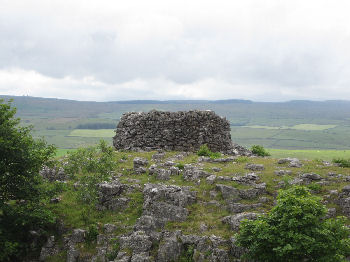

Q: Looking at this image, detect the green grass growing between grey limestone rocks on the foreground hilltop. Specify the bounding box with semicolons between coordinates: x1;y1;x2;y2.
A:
42;146;350;261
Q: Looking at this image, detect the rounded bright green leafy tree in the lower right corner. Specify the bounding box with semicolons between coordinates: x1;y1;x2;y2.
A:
236;186;350;262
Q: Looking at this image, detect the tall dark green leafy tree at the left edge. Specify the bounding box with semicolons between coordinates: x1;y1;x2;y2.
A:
0;100;55;261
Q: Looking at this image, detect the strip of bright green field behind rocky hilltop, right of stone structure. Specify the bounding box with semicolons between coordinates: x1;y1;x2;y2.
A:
267;149;350;161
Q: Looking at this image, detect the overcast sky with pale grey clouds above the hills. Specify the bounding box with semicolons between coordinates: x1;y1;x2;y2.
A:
0;0;350;101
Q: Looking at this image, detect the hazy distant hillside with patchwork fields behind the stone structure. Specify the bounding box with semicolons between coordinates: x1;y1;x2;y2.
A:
0;96;350;149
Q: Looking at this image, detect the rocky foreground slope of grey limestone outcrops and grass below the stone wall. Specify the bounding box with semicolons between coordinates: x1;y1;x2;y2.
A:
40;151;350;262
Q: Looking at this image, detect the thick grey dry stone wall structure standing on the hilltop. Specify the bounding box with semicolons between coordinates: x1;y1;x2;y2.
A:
113;110;235;154
